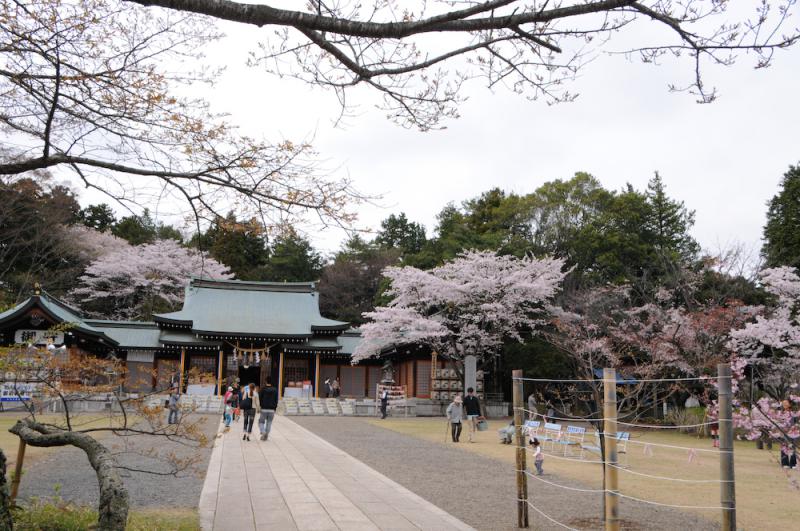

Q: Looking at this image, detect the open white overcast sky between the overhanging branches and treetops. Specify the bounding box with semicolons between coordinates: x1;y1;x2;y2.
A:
83;7;800;258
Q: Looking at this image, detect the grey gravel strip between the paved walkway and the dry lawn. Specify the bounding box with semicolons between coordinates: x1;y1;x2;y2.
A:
290;417;718;530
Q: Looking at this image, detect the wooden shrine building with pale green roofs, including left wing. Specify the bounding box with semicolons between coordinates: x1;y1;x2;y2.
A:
0;278;444;399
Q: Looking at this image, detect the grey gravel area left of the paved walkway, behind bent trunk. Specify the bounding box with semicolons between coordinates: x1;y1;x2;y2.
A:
15;415;220;508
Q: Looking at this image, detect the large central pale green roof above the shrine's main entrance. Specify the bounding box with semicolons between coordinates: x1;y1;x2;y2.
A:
155;278;349;337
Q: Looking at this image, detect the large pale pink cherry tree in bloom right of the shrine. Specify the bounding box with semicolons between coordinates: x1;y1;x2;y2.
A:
353;251;567;365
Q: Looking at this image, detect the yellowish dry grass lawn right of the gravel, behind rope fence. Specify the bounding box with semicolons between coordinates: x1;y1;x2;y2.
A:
369;418;800;529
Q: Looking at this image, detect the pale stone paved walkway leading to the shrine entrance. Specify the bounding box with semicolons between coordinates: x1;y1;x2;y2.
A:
200;415;472;531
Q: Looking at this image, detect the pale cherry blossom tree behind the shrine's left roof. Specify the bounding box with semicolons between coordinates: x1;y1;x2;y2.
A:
69;240;232;319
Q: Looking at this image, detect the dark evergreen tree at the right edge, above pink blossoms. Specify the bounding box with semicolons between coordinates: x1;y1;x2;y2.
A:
761;165;800;268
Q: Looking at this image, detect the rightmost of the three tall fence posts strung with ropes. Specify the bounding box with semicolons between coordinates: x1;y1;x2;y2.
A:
717;363;736;531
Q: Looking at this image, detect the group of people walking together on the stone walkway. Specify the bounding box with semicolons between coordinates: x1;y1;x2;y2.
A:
223;378;278;441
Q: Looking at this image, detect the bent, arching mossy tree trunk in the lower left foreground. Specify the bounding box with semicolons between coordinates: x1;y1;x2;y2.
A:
9;420;128;531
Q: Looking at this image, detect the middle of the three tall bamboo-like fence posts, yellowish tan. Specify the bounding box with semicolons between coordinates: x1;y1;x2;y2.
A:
603;369;619;531
